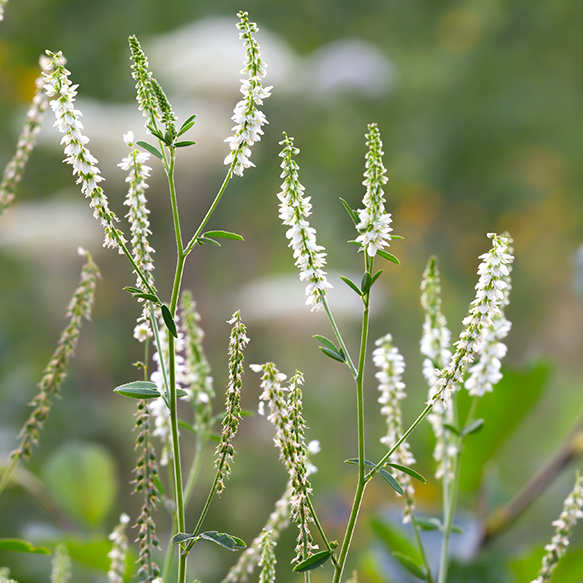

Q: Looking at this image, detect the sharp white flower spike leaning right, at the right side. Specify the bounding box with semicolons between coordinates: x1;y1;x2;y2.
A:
432;233;514;405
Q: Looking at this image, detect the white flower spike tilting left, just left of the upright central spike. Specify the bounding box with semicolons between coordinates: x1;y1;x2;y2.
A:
277;132;332;311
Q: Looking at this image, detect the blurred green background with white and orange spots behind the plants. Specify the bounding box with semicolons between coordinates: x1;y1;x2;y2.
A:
0;0;583;583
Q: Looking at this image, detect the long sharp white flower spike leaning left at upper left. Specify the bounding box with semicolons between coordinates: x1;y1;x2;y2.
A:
42;51;125;253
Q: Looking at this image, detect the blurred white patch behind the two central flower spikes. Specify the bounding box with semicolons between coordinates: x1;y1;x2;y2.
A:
237;272;387;322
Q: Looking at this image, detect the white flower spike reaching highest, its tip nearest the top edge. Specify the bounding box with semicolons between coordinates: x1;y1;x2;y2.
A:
225;12;272;176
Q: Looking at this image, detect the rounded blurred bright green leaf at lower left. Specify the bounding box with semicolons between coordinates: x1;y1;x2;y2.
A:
42;441;118;526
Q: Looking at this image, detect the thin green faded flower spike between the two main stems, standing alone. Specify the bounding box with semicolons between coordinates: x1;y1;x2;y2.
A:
215;311;249;494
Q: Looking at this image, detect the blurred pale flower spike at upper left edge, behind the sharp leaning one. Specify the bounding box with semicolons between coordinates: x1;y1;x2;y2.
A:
0;66;49;216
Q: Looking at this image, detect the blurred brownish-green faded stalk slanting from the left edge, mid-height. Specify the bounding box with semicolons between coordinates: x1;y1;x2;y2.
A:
0;248;100;492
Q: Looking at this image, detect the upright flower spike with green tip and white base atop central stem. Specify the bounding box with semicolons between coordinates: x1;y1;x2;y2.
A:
356;123;393;257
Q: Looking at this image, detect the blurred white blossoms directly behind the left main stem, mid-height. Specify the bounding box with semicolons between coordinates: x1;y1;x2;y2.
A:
148;314;191;466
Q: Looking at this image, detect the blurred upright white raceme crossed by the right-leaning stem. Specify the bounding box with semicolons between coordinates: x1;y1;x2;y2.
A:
421;257;457;478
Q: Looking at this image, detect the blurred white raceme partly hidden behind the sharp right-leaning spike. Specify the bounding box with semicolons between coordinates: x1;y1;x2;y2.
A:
464;238;512;397
